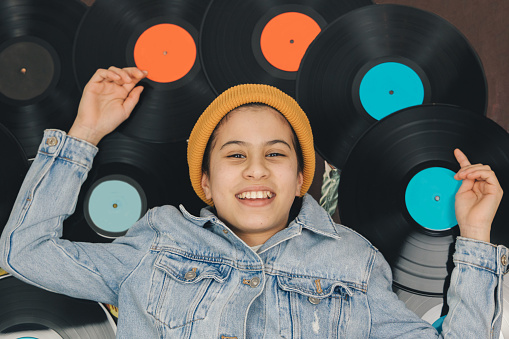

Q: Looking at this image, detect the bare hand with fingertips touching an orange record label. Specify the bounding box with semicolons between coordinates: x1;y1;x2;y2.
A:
68;67;147;145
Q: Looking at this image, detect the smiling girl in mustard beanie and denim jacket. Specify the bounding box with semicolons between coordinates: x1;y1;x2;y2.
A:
0;67;508;339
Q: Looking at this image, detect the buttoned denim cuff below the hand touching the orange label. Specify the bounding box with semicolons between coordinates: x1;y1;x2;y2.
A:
39;129;99;169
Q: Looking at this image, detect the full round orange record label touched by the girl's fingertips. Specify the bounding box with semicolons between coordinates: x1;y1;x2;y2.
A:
134;24;196;83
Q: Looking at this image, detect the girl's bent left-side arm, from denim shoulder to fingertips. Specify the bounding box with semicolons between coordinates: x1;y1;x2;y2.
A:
0;68;151;304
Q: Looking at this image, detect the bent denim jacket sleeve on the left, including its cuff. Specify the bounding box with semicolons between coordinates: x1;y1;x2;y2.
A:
0;130;154;305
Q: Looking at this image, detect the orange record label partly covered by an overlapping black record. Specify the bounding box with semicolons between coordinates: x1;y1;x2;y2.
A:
260;12;321;72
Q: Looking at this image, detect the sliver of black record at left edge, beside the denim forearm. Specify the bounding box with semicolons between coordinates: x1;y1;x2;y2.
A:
0;124;28;234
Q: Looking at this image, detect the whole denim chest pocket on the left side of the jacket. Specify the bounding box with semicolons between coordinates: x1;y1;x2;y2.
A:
147;252;231;329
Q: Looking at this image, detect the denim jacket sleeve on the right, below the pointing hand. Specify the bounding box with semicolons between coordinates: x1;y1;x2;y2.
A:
367;237;508;339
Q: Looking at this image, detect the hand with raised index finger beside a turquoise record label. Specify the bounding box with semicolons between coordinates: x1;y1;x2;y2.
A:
454;149;503;242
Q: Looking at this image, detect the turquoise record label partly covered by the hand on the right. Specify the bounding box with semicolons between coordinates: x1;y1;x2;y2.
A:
405;167;461;231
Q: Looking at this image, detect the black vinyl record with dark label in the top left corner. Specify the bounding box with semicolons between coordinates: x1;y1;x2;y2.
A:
0;0;86;158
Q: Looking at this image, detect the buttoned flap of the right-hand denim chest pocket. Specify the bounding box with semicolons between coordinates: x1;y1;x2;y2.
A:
277;276;353;298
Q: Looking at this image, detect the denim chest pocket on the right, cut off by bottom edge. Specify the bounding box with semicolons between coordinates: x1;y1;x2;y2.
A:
277;276;353;339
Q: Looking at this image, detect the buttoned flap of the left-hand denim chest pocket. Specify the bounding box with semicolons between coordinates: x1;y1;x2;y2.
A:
155;251;232;283
